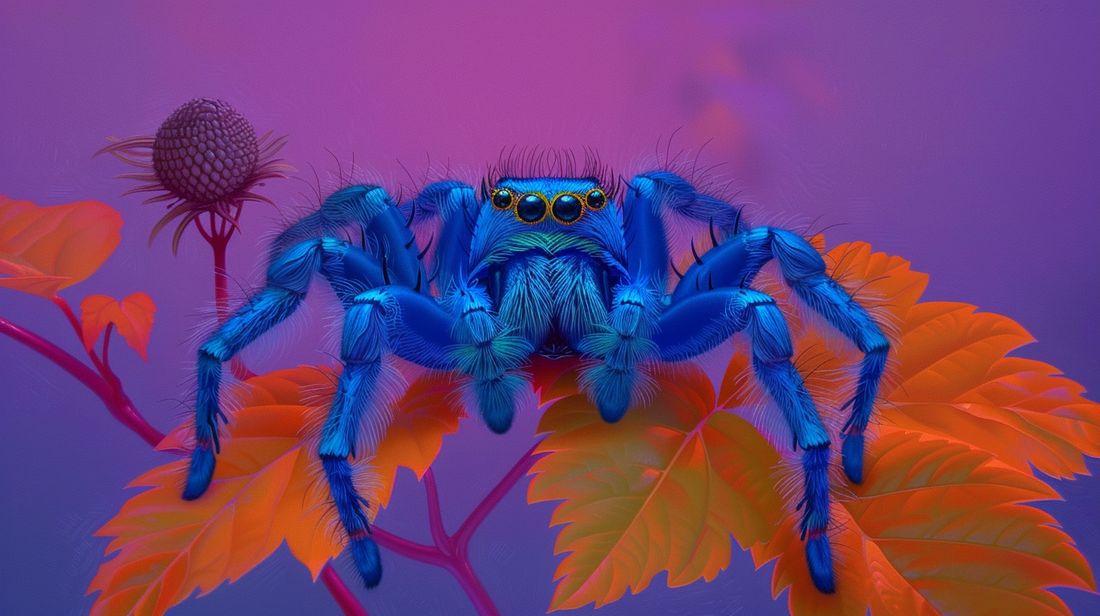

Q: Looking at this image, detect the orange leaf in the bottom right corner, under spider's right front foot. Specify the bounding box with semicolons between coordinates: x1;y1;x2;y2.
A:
752;428;1096;616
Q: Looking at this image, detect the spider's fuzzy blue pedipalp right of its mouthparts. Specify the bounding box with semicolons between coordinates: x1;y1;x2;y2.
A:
580;281;660;424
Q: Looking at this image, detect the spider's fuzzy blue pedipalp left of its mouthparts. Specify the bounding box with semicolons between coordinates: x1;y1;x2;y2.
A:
444;278;531;435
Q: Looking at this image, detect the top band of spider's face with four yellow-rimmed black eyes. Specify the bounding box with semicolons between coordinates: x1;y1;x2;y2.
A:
486;177;611;224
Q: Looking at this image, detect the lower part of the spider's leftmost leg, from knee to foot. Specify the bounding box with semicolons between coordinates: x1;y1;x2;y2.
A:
183;240;323;501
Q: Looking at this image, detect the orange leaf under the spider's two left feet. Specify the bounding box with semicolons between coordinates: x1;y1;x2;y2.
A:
88;366;461;615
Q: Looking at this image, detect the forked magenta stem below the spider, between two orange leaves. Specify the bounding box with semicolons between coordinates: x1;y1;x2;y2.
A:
374;443;541;616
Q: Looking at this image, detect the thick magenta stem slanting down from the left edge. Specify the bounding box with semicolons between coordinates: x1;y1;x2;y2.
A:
0;318;164;447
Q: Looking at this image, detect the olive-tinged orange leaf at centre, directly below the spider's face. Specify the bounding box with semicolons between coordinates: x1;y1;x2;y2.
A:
528;366;781;609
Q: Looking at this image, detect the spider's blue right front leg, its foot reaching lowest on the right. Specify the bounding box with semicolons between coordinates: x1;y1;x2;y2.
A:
653;288;835;593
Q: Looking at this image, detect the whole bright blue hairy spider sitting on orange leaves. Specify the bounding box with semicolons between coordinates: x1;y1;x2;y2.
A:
184;165;889;593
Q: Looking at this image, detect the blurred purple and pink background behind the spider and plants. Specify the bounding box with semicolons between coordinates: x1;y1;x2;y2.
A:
0;1;1100;616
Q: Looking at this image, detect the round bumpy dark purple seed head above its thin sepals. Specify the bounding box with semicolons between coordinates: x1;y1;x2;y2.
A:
153;98;260;205
